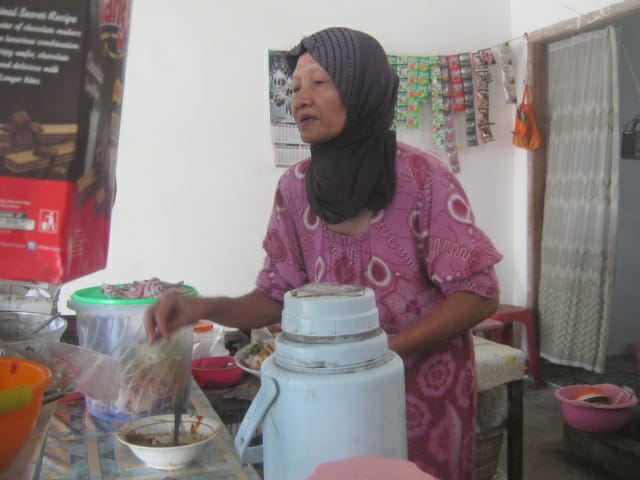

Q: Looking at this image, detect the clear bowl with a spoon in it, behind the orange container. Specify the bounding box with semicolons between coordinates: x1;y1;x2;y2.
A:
0;311;67;362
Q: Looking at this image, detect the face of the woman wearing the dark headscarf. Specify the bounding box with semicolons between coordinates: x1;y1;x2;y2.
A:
292;53;347;144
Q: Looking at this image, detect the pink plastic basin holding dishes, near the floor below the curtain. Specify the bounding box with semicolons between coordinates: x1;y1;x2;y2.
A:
555;383;638;433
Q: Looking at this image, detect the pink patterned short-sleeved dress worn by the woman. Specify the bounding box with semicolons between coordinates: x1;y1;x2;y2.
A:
257;143;502;480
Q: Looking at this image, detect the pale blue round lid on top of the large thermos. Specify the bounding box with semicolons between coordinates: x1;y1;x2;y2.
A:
282;283;380;337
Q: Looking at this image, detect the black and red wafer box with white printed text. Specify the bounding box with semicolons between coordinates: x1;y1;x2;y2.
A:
0;0;132;284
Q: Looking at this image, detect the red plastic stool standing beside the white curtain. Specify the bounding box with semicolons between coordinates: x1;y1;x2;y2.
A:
473;305;543;389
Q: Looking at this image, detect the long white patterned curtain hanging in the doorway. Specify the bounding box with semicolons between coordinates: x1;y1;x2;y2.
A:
539;27;620;372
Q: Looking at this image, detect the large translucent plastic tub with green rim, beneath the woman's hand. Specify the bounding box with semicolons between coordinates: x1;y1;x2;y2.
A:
68;286;197;422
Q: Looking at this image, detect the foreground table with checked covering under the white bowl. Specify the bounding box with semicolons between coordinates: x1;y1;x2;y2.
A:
14;379;261;480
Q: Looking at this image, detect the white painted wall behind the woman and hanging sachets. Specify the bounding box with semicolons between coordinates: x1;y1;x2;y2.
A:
60;0;611;311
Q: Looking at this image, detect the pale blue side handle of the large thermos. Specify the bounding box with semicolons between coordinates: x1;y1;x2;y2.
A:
234;375;278;463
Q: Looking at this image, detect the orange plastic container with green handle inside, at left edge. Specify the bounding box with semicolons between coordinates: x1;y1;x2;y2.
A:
0;357;51;472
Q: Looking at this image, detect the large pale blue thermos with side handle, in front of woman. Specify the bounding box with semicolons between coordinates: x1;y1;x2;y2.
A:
235;284;407;480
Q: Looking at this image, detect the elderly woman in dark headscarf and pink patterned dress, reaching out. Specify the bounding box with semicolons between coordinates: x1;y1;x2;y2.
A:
145;28;501;480
